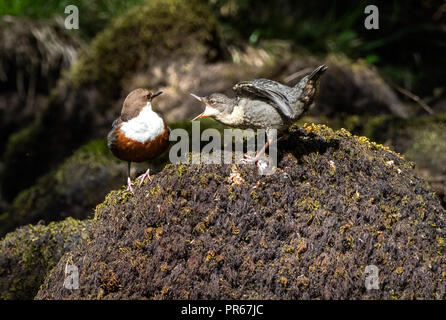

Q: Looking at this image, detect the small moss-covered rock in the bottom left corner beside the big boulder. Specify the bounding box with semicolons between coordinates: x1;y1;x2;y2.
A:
0;218;92;299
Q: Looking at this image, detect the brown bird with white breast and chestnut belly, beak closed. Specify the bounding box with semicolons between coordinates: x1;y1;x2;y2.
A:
107;89;170;192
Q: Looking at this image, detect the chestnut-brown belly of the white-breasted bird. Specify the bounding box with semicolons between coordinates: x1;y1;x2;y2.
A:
111;125;169;162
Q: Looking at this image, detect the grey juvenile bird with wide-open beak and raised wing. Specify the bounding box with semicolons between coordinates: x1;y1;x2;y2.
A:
191;65;327;162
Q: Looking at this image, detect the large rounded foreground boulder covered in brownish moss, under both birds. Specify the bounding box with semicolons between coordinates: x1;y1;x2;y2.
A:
36;125;446;299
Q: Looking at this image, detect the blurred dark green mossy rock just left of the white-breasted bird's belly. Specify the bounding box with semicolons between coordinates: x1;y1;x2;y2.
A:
0;139;127;235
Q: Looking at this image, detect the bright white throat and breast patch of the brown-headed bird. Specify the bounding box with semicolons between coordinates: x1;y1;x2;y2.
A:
121;102;164;143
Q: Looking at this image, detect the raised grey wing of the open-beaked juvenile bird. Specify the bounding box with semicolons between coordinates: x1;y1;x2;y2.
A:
232;79;295;119
